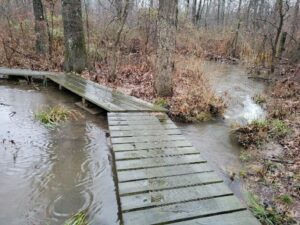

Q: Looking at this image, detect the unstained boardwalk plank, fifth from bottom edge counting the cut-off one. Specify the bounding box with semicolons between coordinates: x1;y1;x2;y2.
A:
118;163;212;182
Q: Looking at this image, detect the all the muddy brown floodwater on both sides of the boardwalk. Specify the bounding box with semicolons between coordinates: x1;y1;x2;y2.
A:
0;63;264;225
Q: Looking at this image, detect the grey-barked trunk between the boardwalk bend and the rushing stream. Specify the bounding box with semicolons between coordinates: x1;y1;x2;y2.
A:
155;0;178;96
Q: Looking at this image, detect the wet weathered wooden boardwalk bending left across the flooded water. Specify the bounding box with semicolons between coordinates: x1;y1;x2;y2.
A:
0;68;260;225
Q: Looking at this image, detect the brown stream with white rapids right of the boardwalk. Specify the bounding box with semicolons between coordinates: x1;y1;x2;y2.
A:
178;62;265;198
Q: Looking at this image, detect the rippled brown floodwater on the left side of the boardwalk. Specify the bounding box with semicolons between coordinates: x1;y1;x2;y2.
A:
0;81;118;225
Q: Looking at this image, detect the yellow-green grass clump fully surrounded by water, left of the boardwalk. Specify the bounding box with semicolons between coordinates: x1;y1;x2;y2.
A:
35;105;81;127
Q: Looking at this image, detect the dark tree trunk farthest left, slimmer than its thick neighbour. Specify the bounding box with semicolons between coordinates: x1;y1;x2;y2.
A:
32;0;47;54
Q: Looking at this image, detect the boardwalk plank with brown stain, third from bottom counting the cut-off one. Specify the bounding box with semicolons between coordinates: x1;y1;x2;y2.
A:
121;183;233;212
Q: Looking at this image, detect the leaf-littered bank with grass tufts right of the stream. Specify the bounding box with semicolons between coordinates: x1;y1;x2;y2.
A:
234;65;300;225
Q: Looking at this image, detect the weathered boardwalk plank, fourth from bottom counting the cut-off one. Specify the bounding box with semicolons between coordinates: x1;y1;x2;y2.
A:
119;171;222;196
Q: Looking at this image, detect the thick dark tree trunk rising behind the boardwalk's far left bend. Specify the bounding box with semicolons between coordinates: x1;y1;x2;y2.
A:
62;0;87;73
